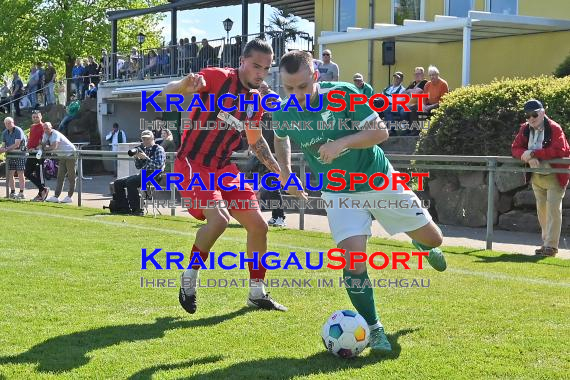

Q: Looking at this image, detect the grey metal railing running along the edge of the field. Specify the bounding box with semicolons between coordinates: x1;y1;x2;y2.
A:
6;150;570;250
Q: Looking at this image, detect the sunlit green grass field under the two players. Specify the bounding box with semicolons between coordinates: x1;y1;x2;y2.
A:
0;201;570;379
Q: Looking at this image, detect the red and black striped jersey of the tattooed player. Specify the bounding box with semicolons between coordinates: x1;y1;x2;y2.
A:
177;67;263;169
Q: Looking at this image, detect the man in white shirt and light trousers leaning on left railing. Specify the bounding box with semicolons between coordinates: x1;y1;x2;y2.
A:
42;122;76;203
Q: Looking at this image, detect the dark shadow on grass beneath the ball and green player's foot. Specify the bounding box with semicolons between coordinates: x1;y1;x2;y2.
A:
182;328;418;380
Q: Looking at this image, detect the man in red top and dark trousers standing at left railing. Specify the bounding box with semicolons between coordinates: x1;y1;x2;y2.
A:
24;111;49;202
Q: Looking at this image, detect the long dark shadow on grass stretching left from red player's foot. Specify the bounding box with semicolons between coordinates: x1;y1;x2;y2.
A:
0;307;251;373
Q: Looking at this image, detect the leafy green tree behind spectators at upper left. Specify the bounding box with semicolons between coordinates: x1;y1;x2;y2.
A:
0;0;164;91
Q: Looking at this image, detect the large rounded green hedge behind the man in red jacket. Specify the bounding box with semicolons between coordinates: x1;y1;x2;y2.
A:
417;76;570;156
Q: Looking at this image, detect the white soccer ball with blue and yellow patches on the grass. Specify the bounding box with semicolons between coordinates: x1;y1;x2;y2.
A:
321;310;370;359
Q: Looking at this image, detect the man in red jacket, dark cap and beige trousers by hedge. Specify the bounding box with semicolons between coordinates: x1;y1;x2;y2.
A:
511;99;570;256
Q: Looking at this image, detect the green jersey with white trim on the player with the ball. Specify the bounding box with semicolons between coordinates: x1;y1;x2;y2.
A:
273;82;390;192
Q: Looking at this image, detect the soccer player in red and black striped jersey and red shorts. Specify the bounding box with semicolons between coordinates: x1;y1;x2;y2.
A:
163;39;287;314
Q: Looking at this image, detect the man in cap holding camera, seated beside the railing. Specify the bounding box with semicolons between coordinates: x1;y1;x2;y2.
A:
113;130;166;216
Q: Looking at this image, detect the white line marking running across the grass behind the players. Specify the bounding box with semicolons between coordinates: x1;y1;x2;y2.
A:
0;208;570;287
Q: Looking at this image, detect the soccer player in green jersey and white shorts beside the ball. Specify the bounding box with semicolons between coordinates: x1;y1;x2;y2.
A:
273;51;447;353
